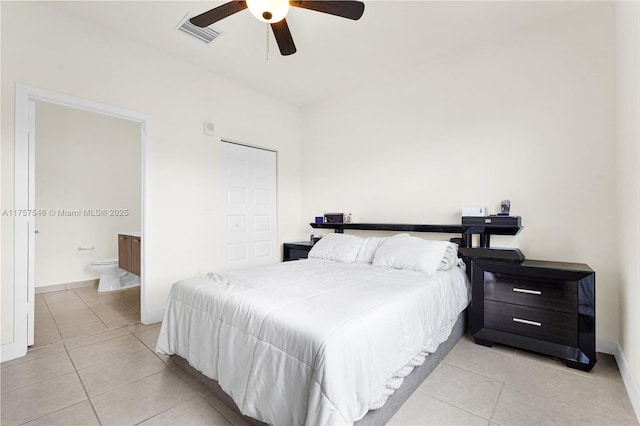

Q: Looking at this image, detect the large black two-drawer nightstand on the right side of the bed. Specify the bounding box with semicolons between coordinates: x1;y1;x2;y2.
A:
471;259;596;371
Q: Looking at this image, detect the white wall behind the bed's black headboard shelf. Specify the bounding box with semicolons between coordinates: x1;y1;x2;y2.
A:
302;2;618;342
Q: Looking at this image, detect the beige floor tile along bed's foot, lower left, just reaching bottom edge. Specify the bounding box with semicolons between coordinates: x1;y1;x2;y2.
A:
92;369;197;425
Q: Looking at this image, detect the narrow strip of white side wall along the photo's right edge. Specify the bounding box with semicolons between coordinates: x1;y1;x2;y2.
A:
616;2;640;419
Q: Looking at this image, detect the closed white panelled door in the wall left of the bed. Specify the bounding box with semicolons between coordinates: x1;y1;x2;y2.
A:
221;142;278;269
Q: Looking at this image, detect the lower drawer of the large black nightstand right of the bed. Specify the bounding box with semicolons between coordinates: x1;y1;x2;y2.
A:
484;300;578;346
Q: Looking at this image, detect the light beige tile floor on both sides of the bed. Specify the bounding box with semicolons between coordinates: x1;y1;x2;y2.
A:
0;289;638;426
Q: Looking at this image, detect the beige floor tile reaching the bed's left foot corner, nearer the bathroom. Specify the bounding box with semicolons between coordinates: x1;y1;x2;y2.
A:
78;349;167;397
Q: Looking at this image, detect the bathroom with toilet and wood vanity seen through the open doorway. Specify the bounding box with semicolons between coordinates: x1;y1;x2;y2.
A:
34;101;142;345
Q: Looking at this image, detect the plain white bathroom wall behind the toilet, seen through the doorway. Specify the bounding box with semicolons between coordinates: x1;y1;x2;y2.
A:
35;102;142;287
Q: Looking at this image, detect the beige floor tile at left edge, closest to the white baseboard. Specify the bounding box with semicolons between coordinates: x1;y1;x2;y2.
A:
2;351;74;394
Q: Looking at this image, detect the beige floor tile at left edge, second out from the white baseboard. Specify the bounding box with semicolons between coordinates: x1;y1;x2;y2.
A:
0;371;87;426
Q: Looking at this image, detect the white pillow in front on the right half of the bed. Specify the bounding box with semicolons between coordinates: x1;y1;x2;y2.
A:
372;236;457;275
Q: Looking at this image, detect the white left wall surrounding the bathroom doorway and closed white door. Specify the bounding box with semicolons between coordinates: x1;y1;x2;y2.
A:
0;1;301;343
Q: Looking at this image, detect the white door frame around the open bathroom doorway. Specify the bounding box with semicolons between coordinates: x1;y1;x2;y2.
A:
2;84;152;361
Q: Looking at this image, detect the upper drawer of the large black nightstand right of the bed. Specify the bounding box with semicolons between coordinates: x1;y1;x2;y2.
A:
484;271;578;313
